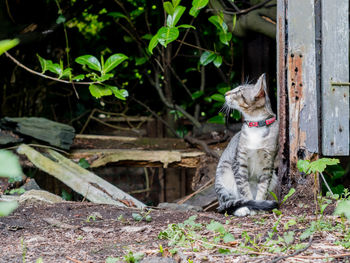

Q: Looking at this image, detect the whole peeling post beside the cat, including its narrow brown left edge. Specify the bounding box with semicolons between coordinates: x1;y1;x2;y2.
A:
277;0;319;182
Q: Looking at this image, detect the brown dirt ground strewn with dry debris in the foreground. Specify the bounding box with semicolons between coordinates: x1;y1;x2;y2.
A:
0;202;350;263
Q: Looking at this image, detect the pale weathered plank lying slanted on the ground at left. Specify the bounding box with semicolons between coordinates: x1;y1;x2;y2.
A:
17;144;145;208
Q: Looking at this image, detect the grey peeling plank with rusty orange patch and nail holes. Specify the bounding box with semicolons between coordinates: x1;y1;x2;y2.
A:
287;0;319;174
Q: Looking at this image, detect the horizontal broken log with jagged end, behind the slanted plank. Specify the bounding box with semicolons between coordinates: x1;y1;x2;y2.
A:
69;149;205;168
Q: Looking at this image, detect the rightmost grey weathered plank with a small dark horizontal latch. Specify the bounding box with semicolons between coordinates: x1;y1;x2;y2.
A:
322;0;349;155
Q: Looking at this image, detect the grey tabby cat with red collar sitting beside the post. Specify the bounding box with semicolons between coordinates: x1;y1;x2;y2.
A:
215;74;278;216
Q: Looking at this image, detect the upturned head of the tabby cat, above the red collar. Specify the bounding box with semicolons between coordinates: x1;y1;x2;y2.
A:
225;74;274;117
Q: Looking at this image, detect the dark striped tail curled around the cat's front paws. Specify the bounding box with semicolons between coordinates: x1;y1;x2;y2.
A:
218;199;278;214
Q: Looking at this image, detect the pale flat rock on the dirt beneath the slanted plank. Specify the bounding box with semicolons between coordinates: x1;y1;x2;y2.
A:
18;190;64;205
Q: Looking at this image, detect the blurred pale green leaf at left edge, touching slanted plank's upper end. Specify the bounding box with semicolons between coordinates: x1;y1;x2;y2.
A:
0;150;22;179
